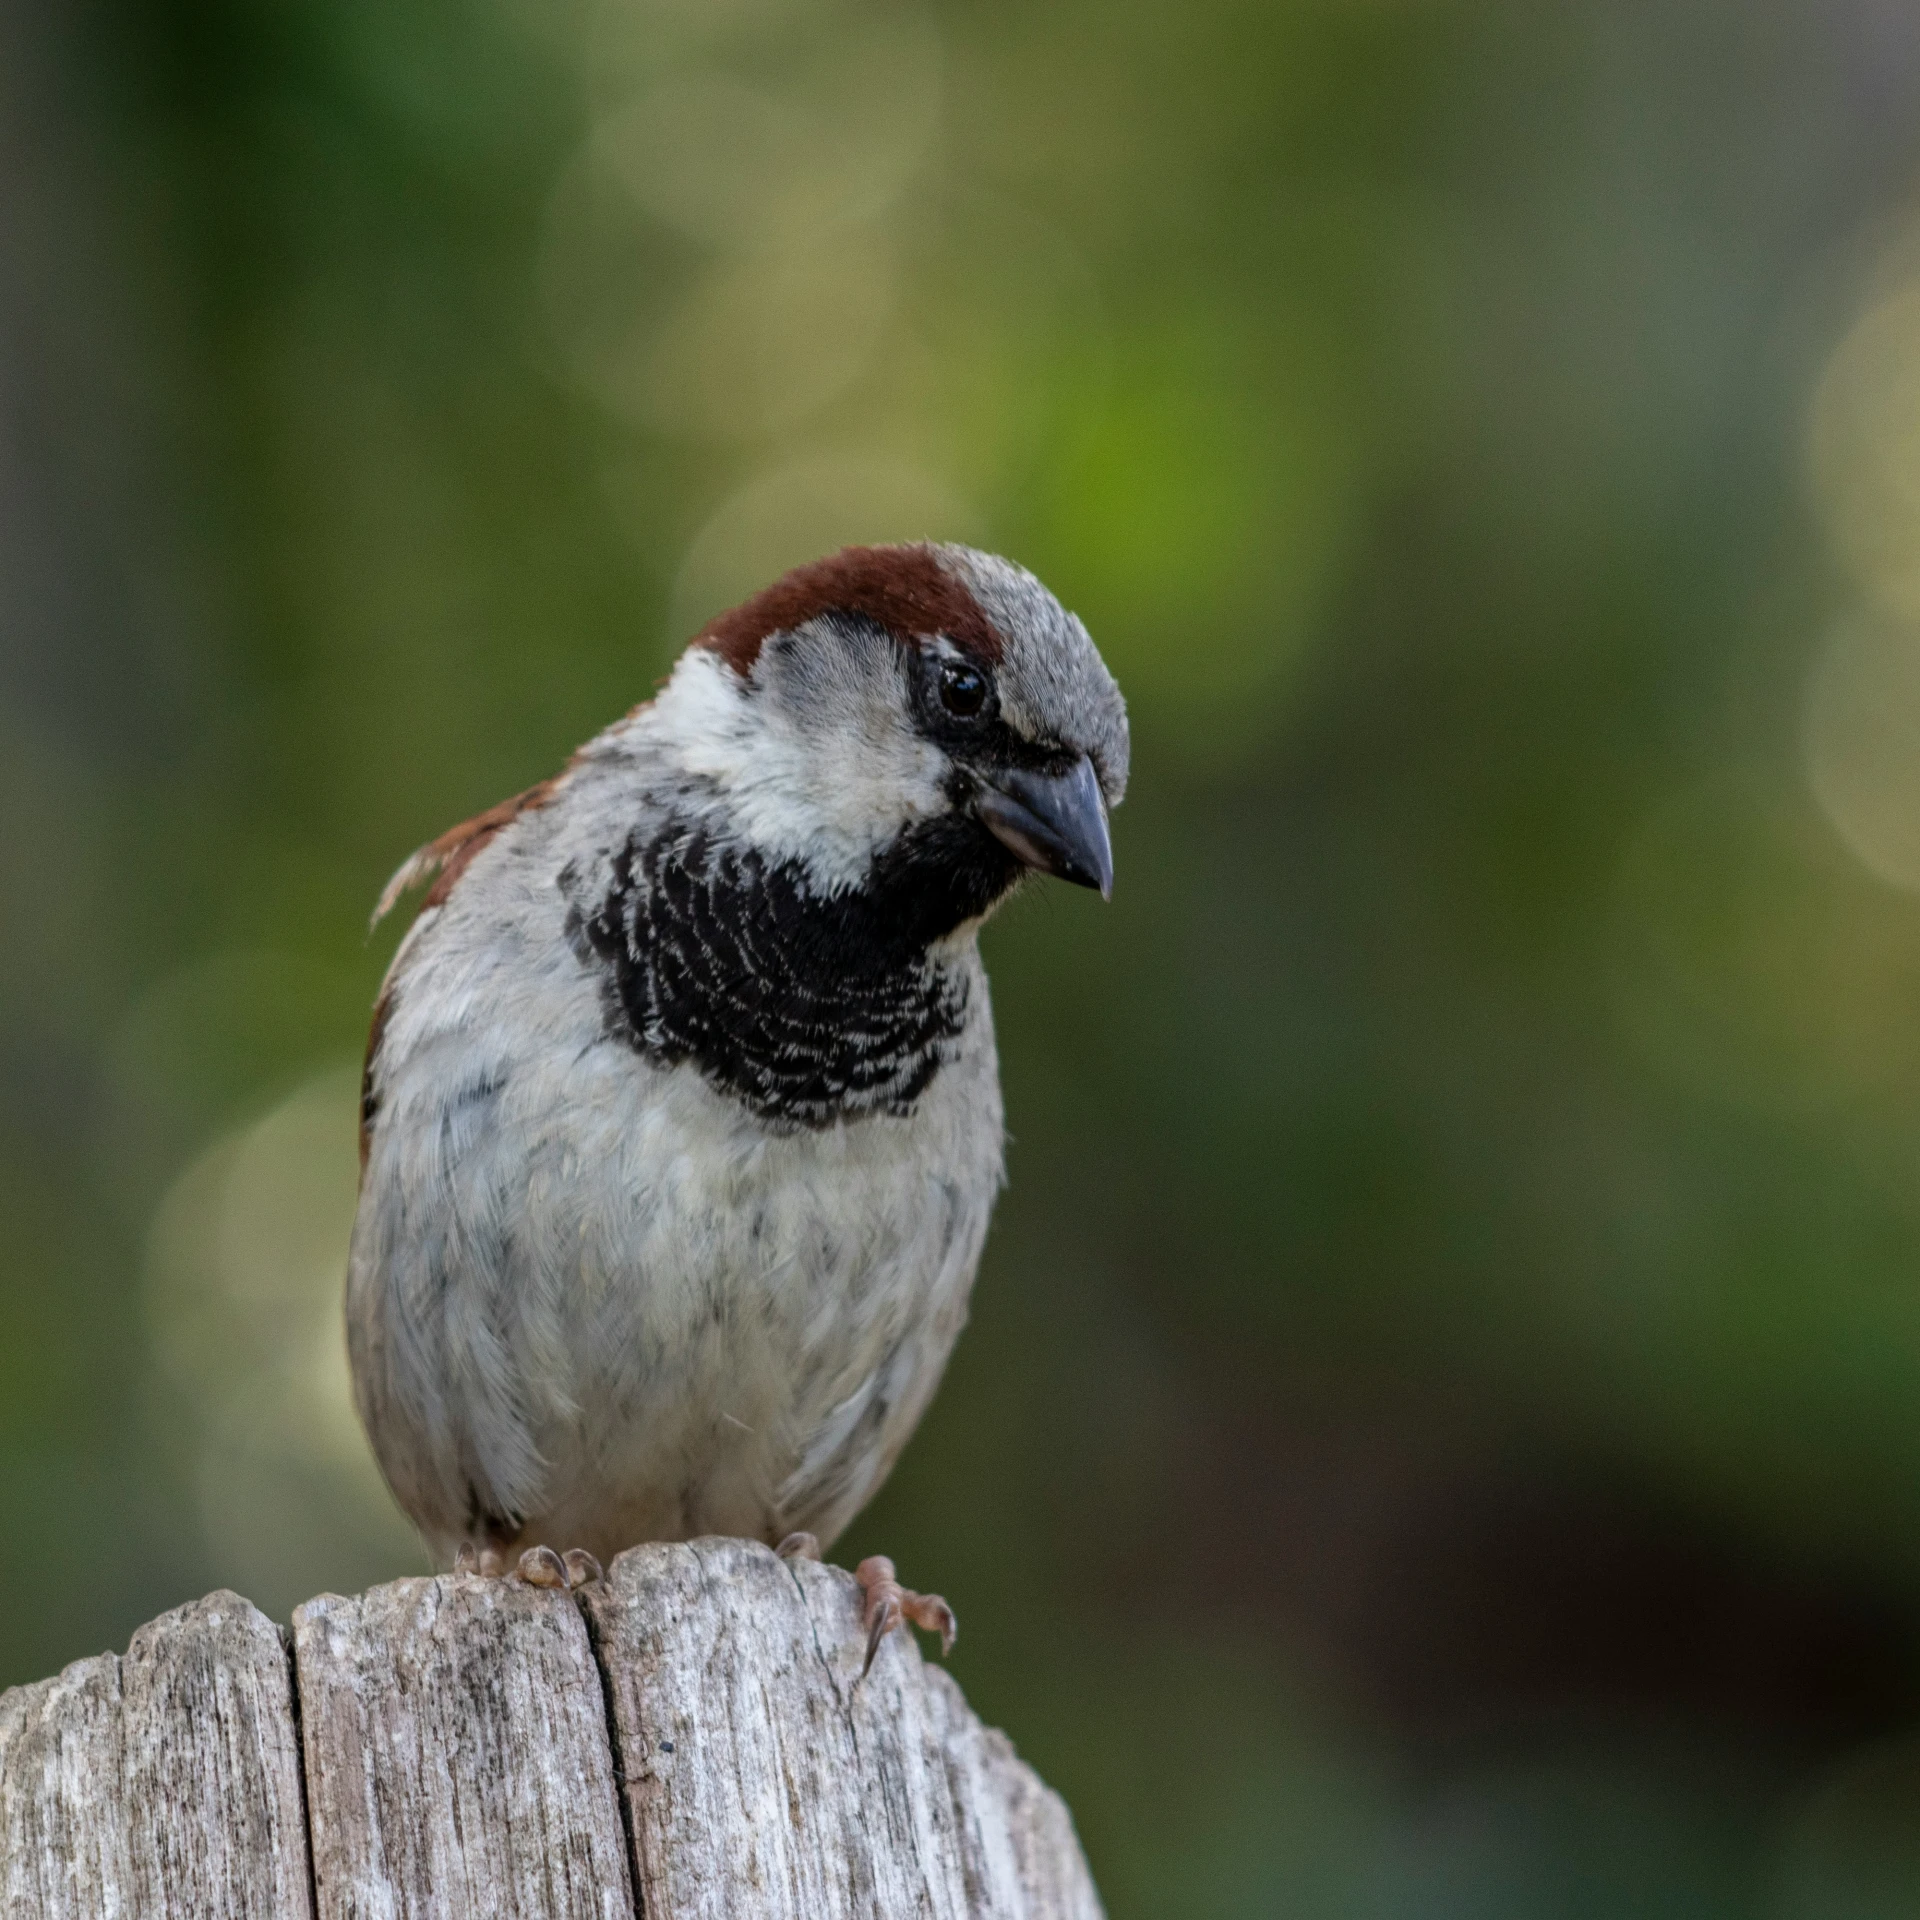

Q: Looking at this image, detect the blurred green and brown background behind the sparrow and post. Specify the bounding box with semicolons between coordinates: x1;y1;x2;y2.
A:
11;0;1920;1920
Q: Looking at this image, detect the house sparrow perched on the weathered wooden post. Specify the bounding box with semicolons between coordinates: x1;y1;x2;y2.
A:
346;545;1127;1657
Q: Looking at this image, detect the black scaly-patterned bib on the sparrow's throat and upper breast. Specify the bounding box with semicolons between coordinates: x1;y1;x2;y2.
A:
561;814;1020;1127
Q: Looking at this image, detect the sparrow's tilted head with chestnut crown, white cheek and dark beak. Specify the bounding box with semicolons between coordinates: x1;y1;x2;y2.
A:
655;545;1127;924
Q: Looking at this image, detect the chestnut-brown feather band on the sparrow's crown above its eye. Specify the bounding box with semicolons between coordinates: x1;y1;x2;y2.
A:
693;543;1002;674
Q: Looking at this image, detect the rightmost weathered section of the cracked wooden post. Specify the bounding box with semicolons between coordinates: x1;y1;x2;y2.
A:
584;1540;1100;1920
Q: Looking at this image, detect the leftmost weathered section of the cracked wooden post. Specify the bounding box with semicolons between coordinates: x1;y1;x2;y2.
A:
0;1594;313;1920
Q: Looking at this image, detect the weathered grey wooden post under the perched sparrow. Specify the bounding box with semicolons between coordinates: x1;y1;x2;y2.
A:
0;1540;1100;1920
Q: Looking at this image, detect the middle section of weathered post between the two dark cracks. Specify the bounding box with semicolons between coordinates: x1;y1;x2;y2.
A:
294;1574;634;1920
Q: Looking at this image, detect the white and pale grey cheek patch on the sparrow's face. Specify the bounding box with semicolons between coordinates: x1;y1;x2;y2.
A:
653;634;948;889
